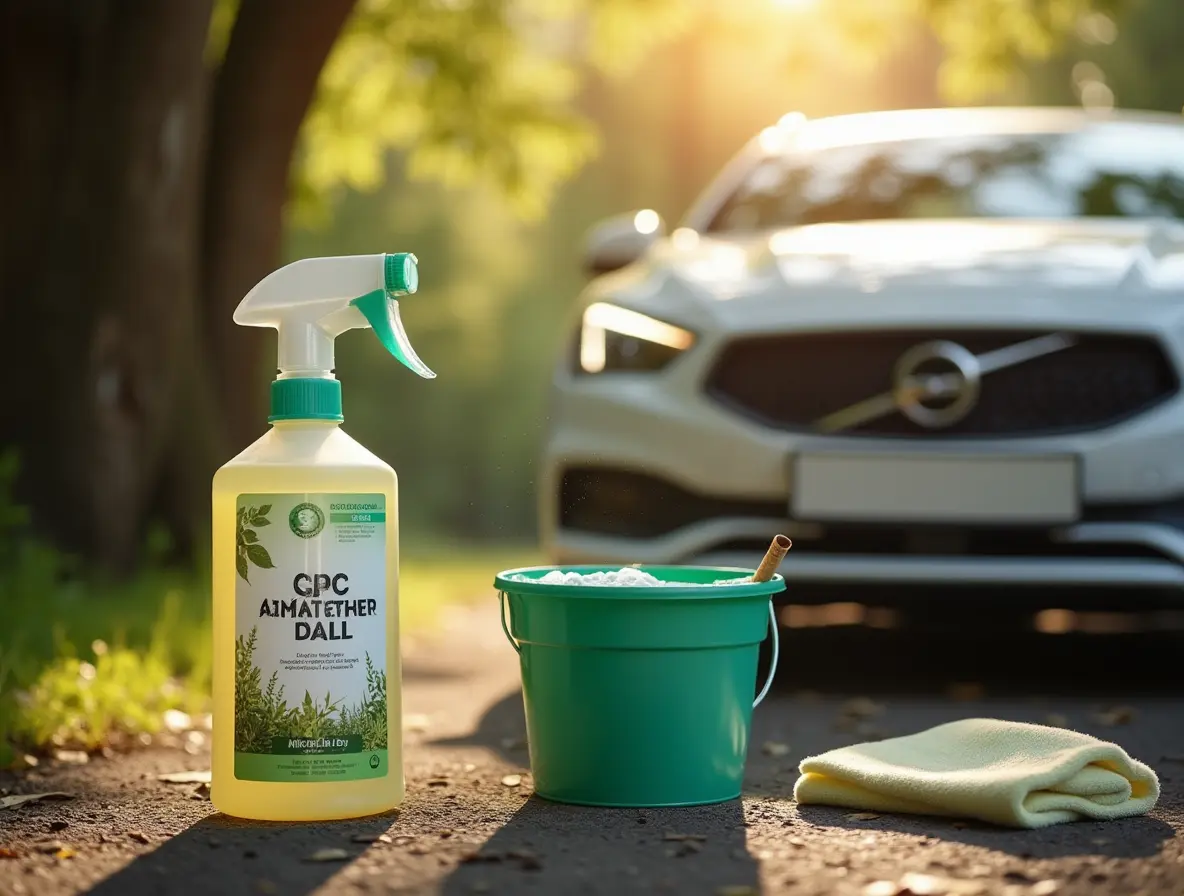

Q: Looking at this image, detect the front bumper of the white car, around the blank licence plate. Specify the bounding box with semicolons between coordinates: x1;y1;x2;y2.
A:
540;343;1184;589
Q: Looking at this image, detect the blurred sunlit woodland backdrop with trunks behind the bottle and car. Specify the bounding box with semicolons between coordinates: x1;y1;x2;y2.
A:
0;0;1146;569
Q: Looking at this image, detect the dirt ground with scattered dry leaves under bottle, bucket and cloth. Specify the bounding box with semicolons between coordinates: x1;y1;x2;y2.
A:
0;607;1184;896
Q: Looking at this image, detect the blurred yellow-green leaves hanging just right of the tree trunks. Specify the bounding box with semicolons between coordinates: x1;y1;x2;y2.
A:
292;0;688;224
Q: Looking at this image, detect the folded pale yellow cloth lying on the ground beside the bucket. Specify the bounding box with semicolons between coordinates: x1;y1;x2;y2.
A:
793;718;1159;827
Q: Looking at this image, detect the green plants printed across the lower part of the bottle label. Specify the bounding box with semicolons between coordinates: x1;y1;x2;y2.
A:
234;629;387;753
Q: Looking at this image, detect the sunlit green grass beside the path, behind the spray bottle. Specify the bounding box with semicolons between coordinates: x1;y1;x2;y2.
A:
0;485;536;768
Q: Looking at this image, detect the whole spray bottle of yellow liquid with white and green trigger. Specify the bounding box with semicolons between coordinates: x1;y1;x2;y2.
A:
211;253;436;821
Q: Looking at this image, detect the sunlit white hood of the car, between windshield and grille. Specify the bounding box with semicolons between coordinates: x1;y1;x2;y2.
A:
591;219;1184;329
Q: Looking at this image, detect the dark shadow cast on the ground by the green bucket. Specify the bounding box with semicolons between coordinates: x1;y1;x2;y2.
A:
442;797;759;896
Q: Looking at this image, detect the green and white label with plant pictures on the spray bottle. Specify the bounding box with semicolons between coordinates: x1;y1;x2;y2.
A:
234;494;388;784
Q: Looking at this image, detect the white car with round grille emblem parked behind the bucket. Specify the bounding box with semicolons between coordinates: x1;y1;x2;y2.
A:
540;109;1184;597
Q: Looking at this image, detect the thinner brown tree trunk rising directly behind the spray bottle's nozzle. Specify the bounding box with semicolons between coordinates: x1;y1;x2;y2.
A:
202;0;355;451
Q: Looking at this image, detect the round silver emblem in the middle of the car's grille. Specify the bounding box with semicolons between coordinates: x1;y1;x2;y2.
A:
893;340;983;430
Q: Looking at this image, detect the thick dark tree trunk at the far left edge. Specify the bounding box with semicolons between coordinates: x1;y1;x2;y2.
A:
0;0;211;569
